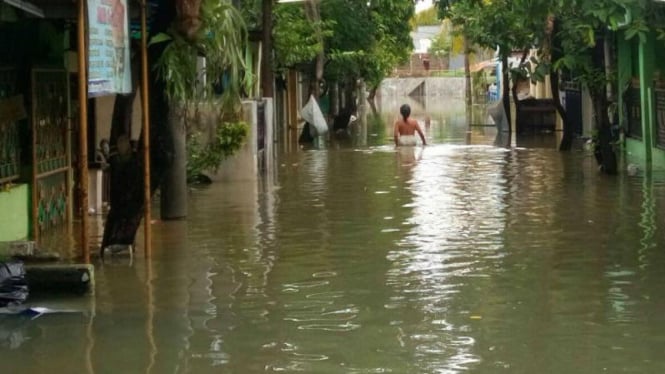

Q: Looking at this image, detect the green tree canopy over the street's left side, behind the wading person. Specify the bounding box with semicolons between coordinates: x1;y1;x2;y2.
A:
273;0;415;93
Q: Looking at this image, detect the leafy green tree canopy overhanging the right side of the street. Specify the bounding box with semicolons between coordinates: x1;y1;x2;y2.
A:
437;0;665;86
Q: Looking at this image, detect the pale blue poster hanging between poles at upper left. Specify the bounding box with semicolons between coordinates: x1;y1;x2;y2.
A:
88;0;132;97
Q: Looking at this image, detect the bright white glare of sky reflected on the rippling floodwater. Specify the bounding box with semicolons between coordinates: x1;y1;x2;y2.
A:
386;146;504;372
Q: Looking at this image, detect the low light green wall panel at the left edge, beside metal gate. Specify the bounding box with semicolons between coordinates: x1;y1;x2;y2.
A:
0;184;30;242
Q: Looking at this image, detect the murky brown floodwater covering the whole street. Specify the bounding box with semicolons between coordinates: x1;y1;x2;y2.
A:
0;103;665;374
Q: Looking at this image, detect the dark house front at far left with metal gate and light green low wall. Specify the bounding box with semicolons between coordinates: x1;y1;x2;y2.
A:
0;13;75;244
